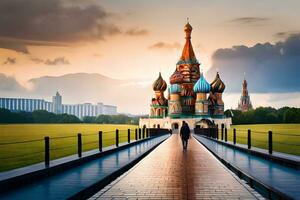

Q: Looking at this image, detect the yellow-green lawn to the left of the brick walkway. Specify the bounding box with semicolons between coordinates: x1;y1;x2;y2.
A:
0;124;137;171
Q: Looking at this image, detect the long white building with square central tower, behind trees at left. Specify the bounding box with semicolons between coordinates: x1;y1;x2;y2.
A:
0;92;118;119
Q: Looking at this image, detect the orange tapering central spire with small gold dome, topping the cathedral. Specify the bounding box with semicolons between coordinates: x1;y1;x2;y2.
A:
180;22;196;61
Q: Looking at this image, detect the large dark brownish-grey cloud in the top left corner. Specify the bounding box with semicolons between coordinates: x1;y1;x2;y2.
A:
0;0;121;53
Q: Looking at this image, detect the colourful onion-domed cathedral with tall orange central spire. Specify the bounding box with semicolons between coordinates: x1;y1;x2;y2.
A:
139;23;231;129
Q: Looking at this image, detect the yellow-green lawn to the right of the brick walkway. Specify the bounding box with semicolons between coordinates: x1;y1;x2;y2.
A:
224;124;300;155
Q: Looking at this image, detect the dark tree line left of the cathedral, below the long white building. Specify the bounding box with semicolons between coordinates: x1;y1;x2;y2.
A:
0;108;139;124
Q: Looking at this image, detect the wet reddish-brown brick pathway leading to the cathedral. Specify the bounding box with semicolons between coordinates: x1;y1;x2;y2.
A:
91;134;256;199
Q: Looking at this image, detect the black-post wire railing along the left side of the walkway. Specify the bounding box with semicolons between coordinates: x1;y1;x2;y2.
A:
0;128;169;171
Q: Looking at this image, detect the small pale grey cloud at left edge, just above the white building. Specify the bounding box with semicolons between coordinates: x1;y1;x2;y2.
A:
0;73;24;92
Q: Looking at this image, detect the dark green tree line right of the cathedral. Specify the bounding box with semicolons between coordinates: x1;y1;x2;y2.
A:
225;107;300;124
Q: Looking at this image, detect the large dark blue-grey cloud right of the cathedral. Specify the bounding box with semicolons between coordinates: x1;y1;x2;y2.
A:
207;34;300;93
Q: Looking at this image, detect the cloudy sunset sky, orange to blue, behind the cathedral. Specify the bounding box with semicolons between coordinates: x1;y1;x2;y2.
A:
0;0;300;114
